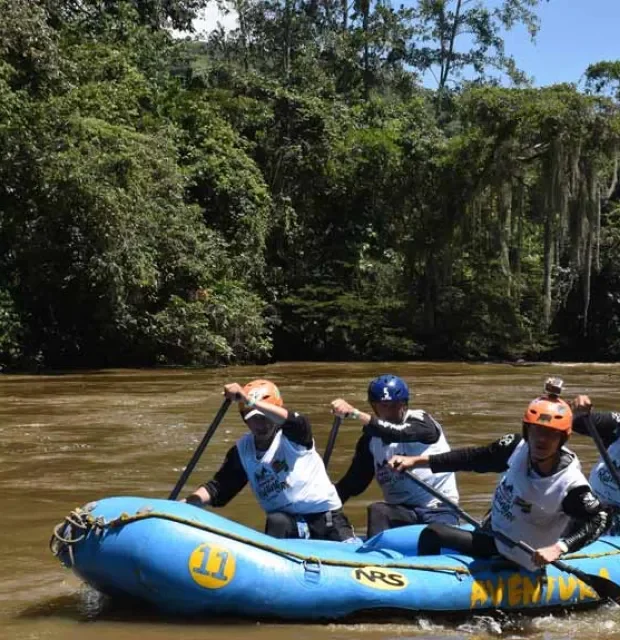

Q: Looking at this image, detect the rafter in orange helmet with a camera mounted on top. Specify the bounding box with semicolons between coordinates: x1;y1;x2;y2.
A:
388;396;608;571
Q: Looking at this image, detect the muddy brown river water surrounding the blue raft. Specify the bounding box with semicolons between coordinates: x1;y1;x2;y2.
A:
0;363;620;640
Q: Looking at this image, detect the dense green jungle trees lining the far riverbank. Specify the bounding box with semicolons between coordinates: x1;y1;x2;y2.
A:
0;0;620;371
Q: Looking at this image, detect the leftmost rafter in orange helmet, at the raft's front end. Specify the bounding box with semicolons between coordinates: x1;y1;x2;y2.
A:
185;380;354;541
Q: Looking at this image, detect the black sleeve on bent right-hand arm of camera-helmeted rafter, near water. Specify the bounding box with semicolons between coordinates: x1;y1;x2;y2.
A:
562;486;609;551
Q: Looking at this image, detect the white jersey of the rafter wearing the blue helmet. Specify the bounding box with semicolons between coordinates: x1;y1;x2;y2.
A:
370;409;459;509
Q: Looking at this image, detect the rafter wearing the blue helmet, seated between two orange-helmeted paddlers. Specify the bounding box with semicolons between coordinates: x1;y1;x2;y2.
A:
331;374;459;538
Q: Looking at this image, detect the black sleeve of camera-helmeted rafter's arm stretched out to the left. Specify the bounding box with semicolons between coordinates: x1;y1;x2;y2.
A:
429;433;521;473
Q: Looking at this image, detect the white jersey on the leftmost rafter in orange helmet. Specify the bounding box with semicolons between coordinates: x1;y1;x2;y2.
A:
237;430;342;515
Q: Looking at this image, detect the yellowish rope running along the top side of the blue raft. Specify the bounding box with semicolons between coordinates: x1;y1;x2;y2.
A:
50;508;620;579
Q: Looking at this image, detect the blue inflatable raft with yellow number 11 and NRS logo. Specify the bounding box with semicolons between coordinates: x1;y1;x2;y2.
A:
51;497;620;620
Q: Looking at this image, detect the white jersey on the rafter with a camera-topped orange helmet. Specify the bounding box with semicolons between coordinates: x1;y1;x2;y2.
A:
491;440;589;571
